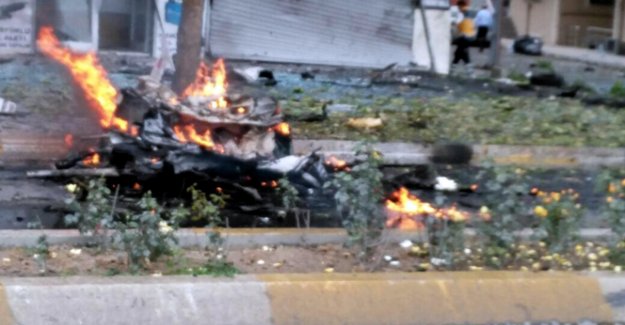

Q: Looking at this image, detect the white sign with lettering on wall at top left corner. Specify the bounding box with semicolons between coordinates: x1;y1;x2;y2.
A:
0;0;33;54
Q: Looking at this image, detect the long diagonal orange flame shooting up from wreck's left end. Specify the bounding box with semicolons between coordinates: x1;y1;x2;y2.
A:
37;27;128;132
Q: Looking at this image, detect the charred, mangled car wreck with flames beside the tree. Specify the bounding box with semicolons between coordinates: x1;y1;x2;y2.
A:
38;28;335;224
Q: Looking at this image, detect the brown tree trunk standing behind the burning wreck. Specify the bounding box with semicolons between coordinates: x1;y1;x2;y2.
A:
172;0;204;95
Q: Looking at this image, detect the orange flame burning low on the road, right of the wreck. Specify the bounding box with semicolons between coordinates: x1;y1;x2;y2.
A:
385;187;468;230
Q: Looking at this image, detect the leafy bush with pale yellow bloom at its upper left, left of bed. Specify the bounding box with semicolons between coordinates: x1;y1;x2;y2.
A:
65;178;119;248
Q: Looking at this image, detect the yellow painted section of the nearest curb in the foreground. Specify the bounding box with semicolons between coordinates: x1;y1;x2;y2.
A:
257;272;613;325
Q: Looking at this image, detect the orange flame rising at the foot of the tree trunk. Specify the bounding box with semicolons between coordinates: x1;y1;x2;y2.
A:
182;59;228;109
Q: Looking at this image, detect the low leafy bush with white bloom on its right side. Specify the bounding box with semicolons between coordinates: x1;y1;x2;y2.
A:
115;192;178;271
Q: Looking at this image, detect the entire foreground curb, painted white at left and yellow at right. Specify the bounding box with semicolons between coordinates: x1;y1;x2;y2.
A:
0;272;625;325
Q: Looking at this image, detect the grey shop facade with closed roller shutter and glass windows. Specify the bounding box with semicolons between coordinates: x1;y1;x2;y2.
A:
0;0;450;73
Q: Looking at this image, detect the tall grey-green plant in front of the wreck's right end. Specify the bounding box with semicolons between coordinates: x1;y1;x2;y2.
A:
325;144;385;261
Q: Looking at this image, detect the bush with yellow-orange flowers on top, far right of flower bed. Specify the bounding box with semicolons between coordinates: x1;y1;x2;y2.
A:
534;189;583;252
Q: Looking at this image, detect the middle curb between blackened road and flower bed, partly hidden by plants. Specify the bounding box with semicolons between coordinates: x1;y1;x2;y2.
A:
0;228;611;248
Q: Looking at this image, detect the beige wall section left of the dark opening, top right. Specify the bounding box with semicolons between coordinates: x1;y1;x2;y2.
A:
510;0;560;45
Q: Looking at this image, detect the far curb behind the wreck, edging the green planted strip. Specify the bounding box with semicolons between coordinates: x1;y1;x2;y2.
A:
0;135;625;168
